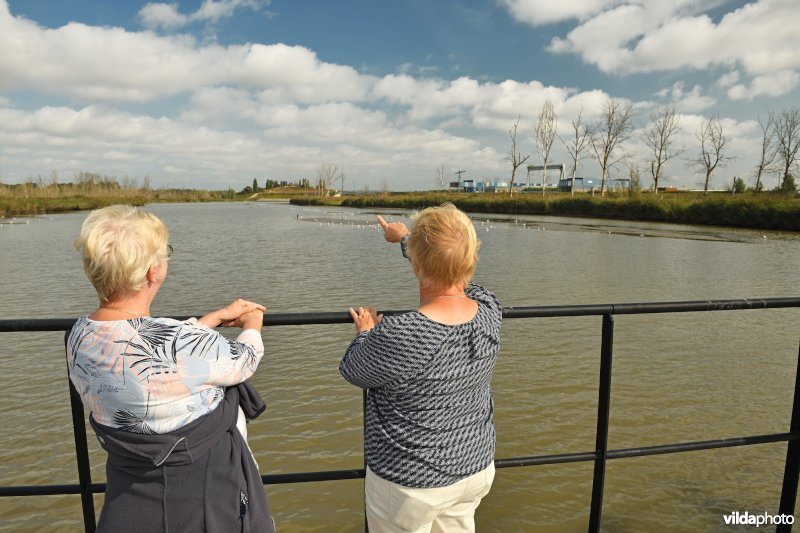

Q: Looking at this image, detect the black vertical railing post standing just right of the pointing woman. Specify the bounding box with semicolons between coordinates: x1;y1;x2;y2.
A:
589;314;614;532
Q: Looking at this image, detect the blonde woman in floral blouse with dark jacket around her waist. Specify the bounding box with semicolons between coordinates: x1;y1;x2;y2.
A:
67;205;274;532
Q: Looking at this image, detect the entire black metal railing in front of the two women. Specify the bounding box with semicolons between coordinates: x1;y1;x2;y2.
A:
0;297;800;533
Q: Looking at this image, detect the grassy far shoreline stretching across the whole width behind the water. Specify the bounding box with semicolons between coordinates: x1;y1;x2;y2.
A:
0;190;800;232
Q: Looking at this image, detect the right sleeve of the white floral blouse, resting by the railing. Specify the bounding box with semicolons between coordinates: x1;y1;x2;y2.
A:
175;319;264;386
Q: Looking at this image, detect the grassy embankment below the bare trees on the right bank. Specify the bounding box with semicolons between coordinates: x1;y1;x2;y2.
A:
291;193;800;231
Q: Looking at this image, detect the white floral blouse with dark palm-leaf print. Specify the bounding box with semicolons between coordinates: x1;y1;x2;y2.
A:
67;317;264;433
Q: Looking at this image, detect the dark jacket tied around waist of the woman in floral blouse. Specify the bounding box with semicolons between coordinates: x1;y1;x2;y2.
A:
89;382;274;533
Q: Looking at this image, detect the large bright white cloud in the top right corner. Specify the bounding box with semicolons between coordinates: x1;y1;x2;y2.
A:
524;0;800;98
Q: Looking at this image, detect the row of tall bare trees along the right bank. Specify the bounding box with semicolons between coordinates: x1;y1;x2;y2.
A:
504;97;800;195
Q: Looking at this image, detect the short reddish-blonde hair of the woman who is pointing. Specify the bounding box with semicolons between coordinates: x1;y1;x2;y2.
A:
408;203;480;288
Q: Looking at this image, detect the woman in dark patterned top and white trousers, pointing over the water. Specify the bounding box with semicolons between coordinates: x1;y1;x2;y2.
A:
339;204;502;533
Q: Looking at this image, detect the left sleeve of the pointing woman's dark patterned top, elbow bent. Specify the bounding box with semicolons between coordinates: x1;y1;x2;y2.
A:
339;317;441;389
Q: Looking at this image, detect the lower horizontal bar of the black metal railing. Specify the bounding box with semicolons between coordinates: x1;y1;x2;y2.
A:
0;433;800;497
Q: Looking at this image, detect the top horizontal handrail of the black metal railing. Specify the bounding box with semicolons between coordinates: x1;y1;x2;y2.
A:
0;297;800;333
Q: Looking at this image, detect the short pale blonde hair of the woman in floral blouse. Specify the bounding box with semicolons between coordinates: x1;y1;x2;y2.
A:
75;205;169;303
